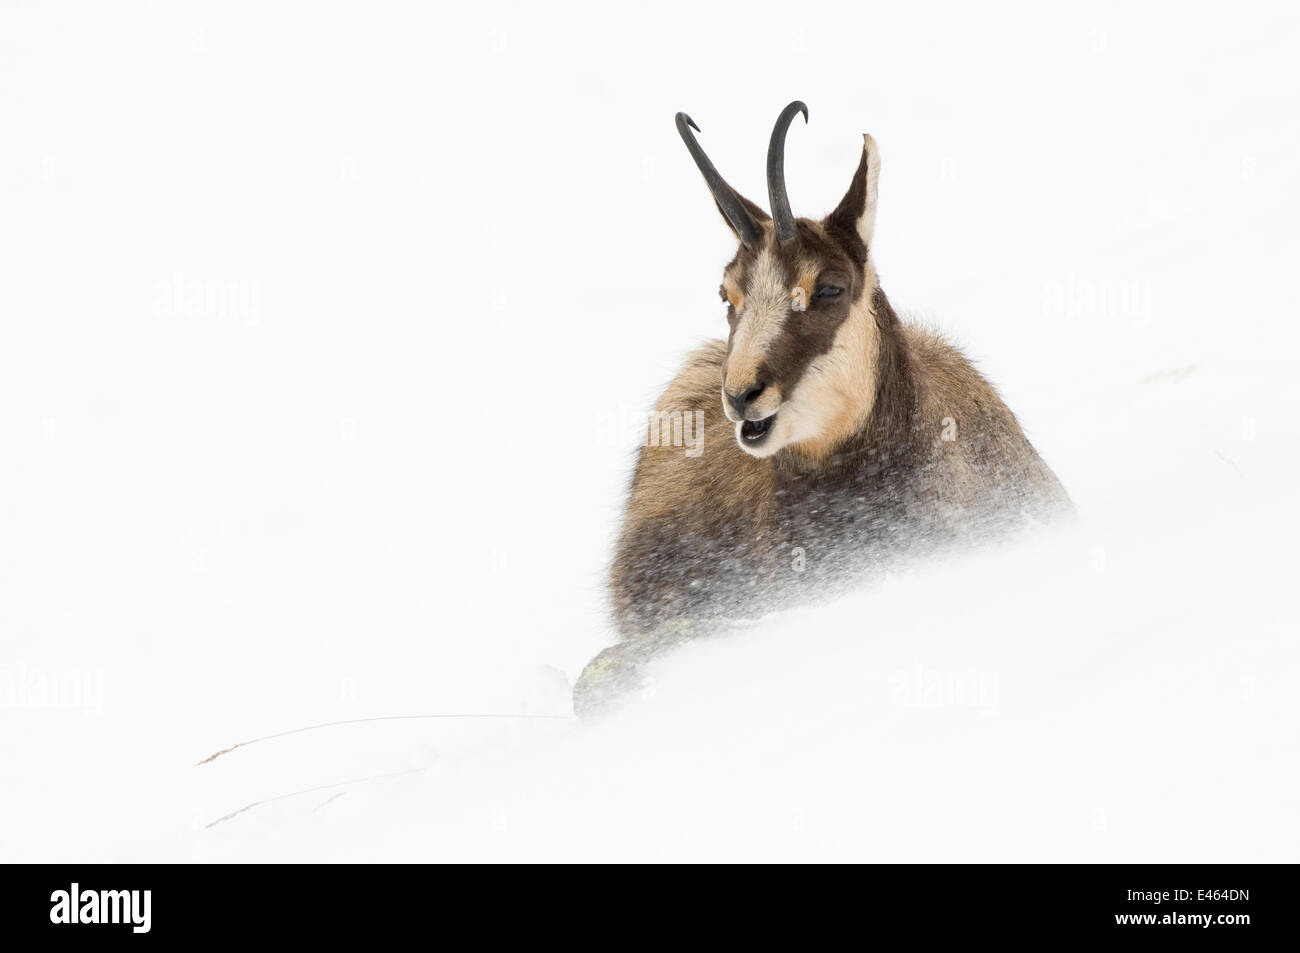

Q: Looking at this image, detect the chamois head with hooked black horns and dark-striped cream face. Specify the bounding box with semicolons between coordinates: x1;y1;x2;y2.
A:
677;103;880;459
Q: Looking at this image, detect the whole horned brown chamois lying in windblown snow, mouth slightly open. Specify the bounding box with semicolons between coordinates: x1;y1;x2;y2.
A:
575;103;1071;714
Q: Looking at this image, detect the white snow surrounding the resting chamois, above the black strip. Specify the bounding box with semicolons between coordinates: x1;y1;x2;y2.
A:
0;3;1300;862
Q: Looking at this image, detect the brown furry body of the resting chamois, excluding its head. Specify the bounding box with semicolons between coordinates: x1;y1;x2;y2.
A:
611;286;1070;637
